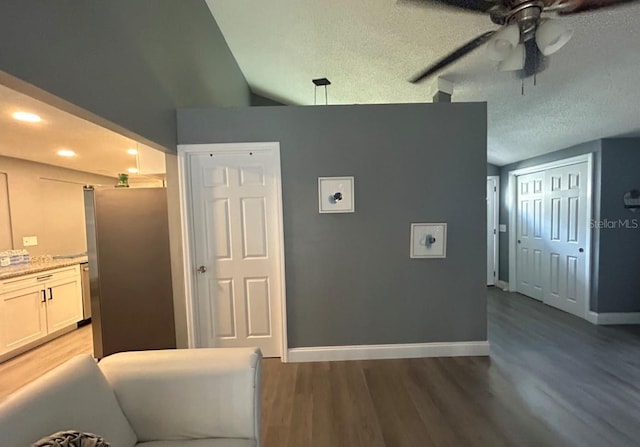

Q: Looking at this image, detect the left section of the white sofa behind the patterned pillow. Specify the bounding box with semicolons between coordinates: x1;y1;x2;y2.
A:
0;355;137;447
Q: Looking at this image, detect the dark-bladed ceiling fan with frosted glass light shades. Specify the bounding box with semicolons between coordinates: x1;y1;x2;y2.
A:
410;0;637;83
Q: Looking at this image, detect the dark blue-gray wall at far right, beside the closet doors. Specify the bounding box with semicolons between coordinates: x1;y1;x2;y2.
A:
594;138;640;312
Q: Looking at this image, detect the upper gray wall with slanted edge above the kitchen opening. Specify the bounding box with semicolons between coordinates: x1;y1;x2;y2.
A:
0;0;250;150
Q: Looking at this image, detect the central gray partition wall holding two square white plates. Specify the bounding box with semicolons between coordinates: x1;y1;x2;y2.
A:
178;103;487;347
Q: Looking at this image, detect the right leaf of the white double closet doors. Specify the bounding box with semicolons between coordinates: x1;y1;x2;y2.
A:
544;163;588;317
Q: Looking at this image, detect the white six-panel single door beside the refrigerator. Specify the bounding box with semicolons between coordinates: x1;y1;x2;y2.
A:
190;144;284;357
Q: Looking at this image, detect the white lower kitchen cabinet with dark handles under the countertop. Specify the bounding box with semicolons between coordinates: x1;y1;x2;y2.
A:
0;265;82;360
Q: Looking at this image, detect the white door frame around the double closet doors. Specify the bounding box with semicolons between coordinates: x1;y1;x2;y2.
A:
507;153;593;319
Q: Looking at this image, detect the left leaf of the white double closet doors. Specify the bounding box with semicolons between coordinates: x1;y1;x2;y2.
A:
516;172;545;301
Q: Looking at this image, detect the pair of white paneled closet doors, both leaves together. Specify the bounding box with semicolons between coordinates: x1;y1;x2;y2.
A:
516;162;589;318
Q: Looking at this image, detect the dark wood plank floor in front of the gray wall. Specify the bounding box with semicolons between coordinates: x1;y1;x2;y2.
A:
262;289;640;447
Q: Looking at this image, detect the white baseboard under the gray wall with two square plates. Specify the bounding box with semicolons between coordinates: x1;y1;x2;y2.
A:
288;341;489;362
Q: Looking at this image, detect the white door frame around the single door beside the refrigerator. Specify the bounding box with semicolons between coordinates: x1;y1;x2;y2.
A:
178;142;288;362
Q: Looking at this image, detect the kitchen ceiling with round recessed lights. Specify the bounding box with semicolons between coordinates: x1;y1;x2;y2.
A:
0;85;164;182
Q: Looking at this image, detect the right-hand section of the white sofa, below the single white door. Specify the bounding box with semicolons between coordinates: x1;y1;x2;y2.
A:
99;348;261;447
